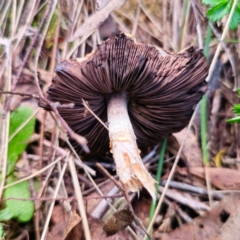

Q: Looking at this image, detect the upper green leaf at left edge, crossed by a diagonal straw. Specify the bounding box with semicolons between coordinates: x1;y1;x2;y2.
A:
7;106;35;174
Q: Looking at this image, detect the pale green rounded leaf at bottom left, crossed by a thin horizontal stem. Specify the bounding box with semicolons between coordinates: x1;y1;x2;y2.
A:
0;178;34;222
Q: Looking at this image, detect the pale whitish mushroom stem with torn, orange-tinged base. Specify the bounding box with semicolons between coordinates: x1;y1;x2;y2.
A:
107;93;156;199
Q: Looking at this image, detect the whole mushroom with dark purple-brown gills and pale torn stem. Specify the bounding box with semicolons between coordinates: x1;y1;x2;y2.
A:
43;33;208;198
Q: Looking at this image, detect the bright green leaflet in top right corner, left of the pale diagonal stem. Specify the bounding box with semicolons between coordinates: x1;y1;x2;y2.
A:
207;1;232;22
